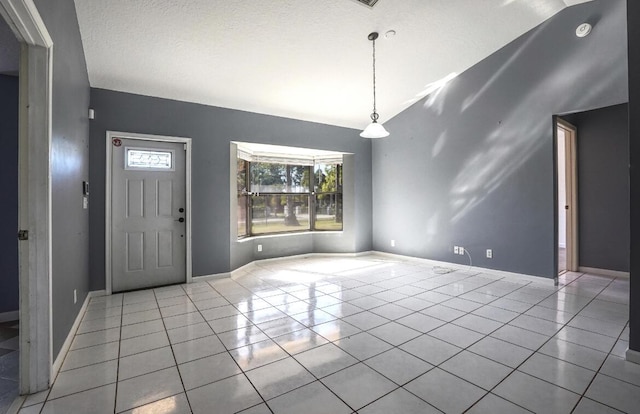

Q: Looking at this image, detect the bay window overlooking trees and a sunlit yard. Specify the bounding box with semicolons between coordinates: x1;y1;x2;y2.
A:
237;146;343;238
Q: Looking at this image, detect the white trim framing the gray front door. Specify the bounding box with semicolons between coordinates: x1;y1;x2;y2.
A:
104;131;193;295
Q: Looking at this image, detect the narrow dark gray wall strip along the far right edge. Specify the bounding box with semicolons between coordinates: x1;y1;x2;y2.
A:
627;0;640;352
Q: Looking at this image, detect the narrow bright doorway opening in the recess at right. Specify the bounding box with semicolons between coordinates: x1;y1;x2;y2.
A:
554;117;578;275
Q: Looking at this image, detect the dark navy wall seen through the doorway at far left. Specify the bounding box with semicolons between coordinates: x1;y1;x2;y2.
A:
0;75;19;313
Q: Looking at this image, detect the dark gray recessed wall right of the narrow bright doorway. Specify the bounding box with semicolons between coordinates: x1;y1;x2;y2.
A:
563;104;630;272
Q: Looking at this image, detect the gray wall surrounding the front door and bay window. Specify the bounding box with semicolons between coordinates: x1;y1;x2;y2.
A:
90;89;371;290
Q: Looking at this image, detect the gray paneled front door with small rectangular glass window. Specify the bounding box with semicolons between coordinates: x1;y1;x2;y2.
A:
111;137;188;292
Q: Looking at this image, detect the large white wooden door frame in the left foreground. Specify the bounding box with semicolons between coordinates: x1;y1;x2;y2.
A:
0;0;55;394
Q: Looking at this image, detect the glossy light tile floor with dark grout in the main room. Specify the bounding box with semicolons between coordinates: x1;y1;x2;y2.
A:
20;256;640;414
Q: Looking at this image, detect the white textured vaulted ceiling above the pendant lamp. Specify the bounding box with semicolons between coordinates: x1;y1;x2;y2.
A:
75;0;588;129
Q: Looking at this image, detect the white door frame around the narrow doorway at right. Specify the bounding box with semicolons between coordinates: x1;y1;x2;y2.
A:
553;116;579;279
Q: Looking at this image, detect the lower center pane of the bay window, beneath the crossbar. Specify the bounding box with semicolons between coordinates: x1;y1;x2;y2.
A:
251;195;310;234
